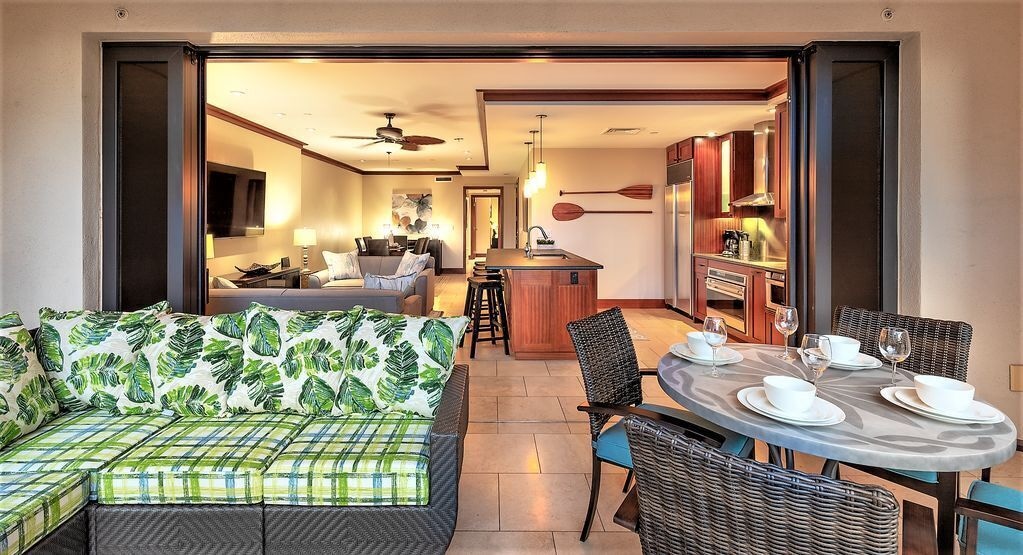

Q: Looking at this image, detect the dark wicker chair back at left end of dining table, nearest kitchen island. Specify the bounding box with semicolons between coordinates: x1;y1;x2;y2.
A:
568;307;642;436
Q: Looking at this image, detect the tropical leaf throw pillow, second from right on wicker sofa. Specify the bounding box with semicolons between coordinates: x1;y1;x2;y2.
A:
234;303;353;415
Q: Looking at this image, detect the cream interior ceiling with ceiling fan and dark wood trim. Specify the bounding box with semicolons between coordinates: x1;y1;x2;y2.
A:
207;61;786;175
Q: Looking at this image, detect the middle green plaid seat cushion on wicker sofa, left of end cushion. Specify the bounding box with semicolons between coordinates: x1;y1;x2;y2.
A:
97;413;309;504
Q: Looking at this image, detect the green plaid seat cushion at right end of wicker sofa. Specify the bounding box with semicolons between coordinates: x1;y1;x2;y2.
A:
263;413;433;505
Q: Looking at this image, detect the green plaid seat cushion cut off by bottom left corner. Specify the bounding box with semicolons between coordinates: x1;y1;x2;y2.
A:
0;472;89;555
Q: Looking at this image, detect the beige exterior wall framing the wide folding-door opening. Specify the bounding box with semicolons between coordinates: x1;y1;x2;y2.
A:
0;0;1023;423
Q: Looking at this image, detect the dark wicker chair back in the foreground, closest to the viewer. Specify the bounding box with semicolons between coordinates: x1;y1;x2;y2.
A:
625;416;899;555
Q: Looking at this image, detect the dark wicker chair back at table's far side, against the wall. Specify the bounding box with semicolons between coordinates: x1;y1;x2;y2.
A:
832;307;973;381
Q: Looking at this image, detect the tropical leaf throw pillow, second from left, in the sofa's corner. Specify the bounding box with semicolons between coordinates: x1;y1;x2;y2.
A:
36;300;171;414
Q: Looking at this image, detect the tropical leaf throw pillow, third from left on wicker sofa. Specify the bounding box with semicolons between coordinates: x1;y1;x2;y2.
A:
135;312;246;417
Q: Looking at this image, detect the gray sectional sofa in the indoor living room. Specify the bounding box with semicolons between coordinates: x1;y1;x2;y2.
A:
206;256;436;316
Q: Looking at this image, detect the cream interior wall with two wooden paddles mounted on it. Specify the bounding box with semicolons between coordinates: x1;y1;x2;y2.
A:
529;148;666;299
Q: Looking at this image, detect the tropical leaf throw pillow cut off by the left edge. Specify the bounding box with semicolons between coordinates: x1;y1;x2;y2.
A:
0;312;60;448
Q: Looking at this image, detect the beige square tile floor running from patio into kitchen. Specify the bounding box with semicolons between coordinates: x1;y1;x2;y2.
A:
436;275;1023;554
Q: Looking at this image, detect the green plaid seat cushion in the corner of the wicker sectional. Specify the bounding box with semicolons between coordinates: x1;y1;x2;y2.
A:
0;409;175;499
